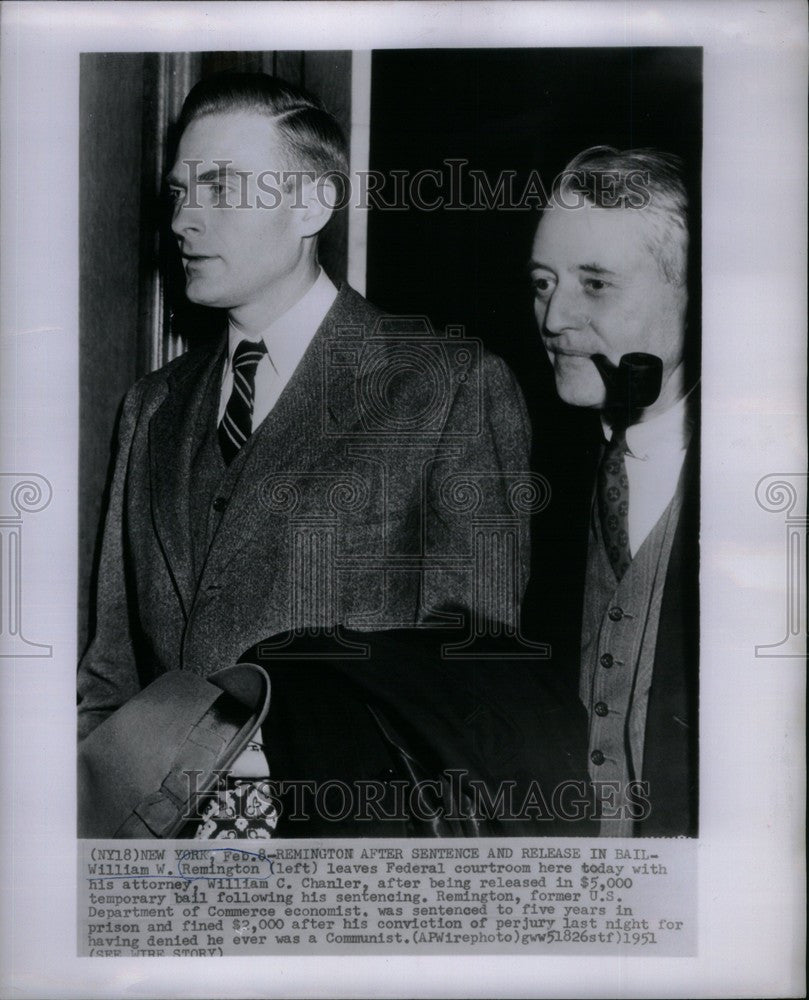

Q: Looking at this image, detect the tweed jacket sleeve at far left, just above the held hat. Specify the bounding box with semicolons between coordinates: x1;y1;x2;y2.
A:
78;383;150;740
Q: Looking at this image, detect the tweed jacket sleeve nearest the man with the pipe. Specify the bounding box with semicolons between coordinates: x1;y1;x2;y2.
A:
419;352;531;624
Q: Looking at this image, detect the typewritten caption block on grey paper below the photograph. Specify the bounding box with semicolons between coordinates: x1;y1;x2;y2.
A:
77;839;697;957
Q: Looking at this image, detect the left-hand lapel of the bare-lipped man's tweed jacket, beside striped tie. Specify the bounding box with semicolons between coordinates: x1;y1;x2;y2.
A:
149;349;224;616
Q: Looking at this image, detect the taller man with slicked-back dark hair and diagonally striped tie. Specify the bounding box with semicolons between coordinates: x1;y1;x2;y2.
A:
79;74;528;836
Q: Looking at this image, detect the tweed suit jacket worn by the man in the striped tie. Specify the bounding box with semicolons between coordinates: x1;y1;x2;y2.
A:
78;286;530;736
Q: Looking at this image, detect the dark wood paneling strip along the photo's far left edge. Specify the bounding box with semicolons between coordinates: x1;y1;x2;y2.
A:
79;54;144;648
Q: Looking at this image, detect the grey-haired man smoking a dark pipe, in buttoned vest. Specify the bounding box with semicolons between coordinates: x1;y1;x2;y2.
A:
528;147;699;836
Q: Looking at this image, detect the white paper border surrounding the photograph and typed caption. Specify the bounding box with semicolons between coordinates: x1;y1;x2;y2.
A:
0;0;807;997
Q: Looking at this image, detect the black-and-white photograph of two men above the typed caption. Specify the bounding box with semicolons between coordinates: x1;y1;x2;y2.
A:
78;48;701;839
